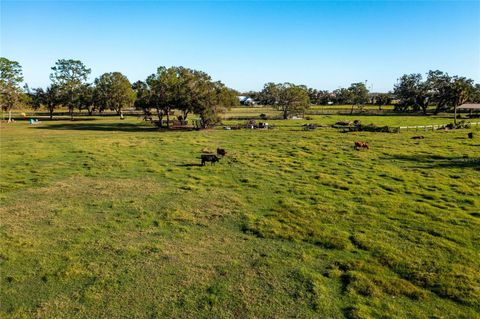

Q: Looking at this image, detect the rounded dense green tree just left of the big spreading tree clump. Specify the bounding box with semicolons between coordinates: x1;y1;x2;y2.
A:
95;72;135;118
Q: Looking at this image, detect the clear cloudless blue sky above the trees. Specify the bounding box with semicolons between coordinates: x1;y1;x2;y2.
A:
0;0;480;91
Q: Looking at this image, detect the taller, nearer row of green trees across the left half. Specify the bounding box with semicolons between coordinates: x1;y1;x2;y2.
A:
0;58;238;127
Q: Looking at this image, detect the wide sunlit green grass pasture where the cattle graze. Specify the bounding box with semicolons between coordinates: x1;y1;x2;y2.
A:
0;112;480;318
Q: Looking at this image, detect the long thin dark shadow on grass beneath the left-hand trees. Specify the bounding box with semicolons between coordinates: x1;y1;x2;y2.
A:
34;119;159;132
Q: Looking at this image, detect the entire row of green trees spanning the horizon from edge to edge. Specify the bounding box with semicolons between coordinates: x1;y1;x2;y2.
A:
0;57;480;127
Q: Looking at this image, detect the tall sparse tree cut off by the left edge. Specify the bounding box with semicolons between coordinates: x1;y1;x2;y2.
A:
0;57;24;123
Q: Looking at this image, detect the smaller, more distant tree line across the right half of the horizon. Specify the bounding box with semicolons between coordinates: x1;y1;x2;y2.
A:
249;74;480;118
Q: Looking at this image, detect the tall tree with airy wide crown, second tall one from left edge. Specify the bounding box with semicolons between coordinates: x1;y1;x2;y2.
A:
50;59;91;120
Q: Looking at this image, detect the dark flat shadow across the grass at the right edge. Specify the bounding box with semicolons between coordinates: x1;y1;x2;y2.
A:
385;155;480;170
